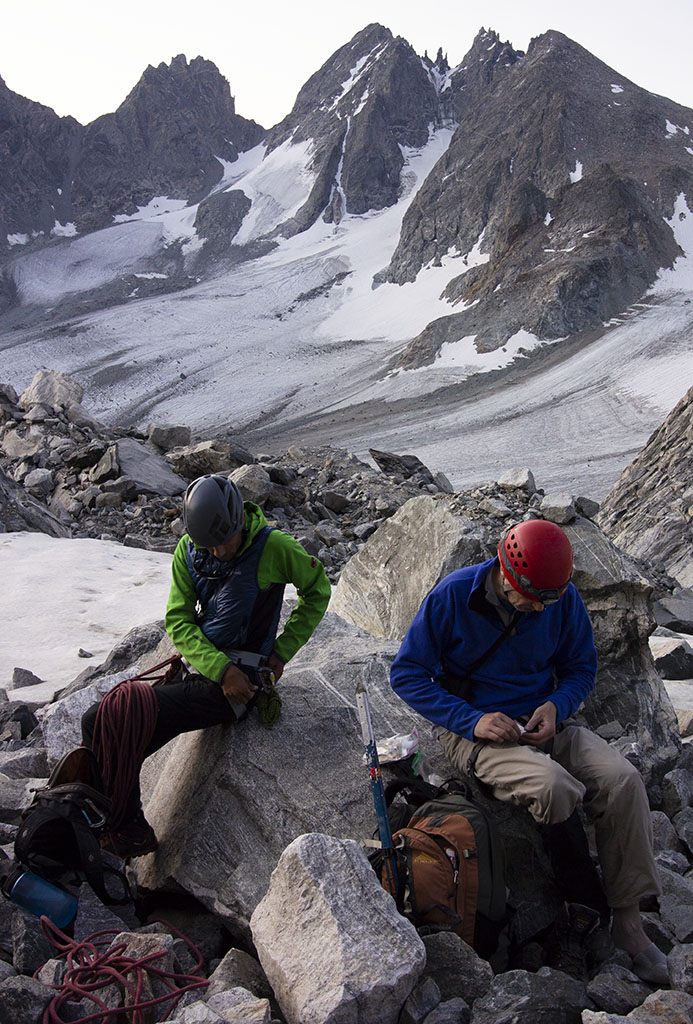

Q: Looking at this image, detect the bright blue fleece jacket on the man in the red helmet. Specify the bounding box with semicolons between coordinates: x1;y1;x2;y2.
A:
390;558;597;739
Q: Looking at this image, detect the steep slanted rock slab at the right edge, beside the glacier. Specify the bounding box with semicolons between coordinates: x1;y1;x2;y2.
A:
598;388;693;588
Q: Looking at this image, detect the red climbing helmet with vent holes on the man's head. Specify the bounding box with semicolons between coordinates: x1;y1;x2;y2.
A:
499;519;572;604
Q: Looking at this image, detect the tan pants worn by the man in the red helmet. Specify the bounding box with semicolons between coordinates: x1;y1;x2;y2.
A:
440;723;661;907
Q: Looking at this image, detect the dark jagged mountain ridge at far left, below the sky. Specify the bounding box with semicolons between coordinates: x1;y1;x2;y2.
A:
0;53;264;248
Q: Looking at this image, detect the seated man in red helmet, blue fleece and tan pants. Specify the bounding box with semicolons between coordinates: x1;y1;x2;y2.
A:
390;519;668;984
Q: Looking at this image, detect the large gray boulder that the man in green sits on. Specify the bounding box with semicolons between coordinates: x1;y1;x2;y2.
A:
135;613;444;930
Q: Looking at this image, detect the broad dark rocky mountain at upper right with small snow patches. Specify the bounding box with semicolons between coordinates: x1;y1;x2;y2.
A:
387;31;693;367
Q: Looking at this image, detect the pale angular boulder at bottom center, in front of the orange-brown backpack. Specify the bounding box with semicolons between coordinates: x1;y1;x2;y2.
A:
251;835;425;1024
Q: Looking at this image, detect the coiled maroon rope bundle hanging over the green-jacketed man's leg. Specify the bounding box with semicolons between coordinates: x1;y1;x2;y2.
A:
92;670;159;830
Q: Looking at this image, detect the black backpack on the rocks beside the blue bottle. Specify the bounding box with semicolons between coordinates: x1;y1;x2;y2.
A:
14;746;130;904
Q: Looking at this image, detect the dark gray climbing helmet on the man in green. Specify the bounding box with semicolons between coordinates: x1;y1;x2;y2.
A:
183;473;246;548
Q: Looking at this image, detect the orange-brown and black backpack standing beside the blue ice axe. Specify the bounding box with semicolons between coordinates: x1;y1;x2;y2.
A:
371;777;508;955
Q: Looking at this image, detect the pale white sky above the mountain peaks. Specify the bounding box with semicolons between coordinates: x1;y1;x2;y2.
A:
0;0;693;127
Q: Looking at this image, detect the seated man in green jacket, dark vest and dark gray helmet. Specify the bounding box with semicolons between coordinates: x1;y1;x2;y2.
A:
82;474;330;857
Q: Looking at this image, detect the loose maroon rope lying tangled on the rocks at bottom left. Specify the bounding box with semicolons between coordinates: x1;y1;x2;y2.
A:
34;916;209;1024
